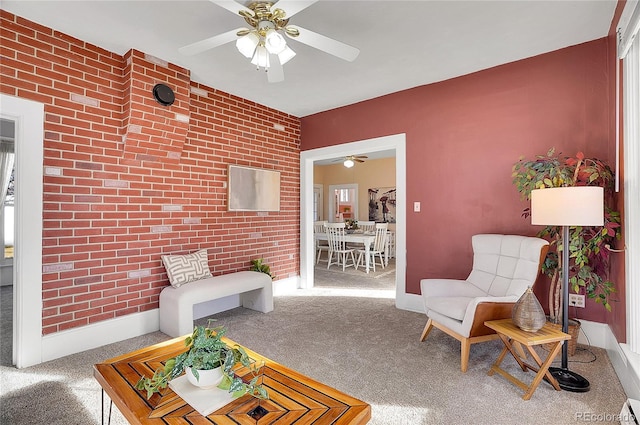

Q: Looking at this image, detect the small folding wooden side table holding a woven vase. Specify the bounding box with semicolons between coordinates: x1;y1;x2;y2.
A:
484;319;571;400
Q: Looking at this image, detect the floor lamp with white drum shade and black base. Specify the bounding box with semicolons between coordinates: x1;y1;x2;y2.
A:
531;186;604;392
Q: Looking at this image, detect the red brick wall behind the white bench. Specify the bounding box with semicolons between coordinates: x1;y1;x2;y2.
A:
0;11;300;334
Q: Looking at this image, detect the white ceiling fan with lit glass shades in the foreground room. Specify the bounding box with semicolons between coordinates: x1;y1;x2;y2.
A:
179;0;360;83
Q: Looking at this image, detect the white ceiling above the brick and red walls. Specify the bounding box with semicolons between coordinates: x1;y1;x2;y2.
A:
2;0;616;117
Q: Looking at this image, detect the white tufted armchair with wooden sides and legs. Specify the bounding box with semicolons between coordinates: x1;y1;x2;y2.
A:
420;234;549;372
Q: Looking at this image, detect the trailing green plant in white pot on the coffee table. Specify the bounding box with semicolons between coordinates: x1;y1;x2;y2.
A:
136;326;269;399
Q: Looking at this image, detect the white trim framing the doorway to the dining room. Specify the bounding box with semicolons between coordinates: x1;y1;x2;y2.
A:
300;133;412;308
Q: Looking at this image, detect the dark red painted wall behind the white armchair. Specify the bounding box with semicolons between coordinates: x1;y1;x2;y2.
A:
301;39;614;322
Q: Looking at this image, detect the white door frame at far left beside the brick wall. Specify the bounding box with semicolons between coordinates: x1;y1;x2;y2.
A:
0;94;44;368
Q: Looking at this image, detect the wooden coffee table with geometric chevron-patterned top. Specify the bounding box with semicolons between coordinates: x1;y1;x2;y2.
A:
93;337;371;425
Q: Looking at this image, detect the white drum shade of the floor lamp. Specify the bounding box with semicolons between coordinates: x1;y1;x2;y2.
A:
531;186;604;226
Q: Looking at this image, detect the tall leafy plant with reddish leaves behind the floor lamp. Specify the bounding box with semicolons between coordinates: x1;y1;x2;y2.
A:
512;148;620;330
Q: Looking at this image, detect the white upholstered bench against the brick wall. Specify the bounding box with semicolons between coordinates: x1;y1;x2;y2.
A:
160;271;273;337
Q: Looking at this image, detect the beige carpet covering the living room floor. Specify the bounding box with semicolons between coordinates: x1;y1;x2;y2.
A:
0;274;626;425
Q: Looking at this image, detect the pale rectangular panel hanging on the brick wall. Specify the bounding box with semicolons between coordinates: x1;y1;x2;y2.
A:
227;165;280;211
